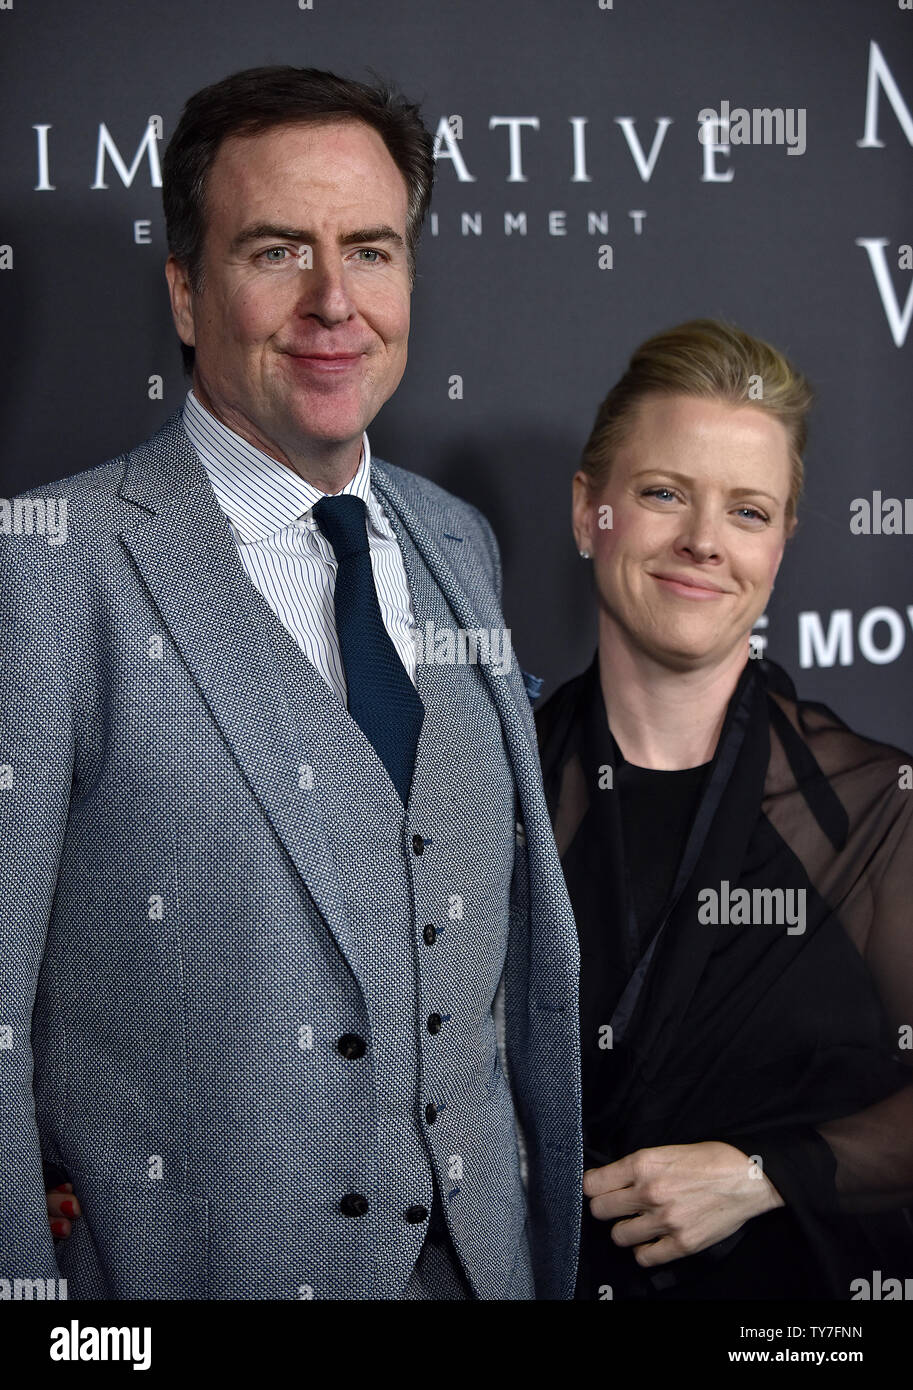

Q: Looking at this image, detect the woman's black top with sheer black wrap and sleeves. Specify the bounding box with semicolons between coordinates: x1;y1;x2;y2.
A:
536;660;913;1298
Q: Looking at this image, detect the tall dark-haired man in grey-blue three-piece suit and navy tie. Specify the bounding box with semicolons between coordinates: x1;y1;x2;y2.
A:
0;68;582;1300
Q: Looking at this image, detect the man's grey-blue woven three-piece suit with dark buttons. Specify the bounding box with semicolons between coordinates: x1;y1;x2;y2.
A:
0;413;582;1300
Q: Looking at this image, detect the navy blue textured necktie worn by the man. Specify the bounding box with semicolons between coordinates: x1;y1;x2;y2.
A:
313;492;425;806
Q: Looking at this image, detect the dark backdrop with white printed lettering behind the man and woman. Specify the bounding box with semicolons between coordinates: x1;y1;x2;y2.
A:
0;0;913;749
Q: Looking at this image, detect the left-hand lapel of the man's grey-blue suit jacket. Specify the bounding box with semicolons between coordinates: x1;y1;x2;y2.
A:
113;413;352;978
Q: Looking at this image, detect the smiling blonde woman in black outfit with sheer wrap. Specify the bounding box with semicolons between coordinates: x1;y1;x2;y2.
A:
538;320;913;1300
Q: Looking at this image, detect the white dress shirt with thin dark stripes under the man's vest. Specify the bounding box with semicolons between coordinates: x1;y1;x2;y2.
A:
182;391;416;705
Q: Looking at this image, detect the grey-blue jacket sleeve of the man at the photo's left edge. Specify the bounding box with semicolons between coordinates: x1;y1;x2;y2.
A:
0;535;74;1279
